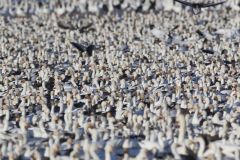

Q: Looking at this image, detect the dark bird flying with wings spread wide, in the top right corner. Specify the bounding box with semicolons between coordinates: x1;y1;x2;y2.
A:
174;0;226;14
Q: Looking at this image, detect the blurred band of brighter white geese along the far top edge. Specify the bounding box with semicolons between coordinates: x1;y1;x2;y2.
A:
0;0;239;17
